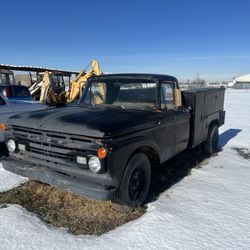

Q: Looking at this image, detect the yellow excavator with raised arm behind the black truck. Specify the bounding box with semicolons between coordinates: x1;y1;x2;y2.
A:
40;60;103;106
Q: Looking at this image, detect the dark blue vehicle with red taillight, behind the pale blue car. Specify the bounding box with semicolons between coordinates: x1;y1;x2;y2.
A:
0;84;32;101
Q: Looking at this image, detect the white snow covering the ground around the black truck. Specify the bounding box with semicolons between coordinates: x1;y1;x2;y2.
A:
0;90;250;250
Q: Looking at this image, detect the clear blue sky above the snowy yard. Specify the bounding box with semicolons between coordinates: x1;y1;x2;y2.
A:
0;0;250;81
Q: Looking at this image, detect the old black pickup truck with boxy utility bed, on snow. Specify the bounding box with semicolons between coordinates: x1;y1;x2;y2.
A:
3;74;225;207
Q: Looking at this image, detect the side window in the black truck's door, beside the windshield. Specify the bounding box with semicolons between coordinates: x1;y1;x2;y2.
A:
161;83;175;109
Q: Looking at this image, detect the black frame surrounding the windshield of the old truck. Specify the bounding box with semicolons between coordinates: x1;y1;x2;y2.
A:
78;76;160;111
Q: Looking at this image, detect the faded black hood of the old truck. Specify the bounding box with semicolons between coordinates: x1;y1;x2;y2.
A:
8;105;156;138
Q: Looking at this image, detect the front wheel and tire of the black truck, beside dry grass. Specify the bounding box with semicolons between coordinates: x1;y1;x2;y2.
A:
113;153;151;212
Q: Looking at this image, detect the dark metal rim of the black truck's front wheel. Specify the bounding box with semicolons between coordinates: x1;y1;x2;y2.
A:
128;169;146;201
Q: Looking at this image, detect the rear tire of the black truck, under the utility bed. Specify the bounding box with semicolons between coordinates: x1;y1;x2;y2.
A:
203;124;219;156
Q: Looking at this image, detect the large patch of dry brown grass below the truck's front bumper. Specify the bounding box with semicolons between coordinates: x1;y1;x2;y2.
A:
0;181;145;235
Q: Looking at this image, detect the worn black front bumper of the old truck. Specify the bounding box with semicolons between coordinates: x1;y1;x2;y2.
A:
1;158;116;200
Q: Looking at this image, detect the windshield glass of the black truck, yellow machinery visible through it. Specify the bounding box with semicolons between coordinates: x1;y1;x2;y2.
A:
80;79;156;109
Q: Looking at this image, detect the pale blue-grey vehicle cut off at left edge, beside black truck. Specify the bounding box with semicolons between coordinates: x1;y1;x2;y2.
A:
0;93;48;142
